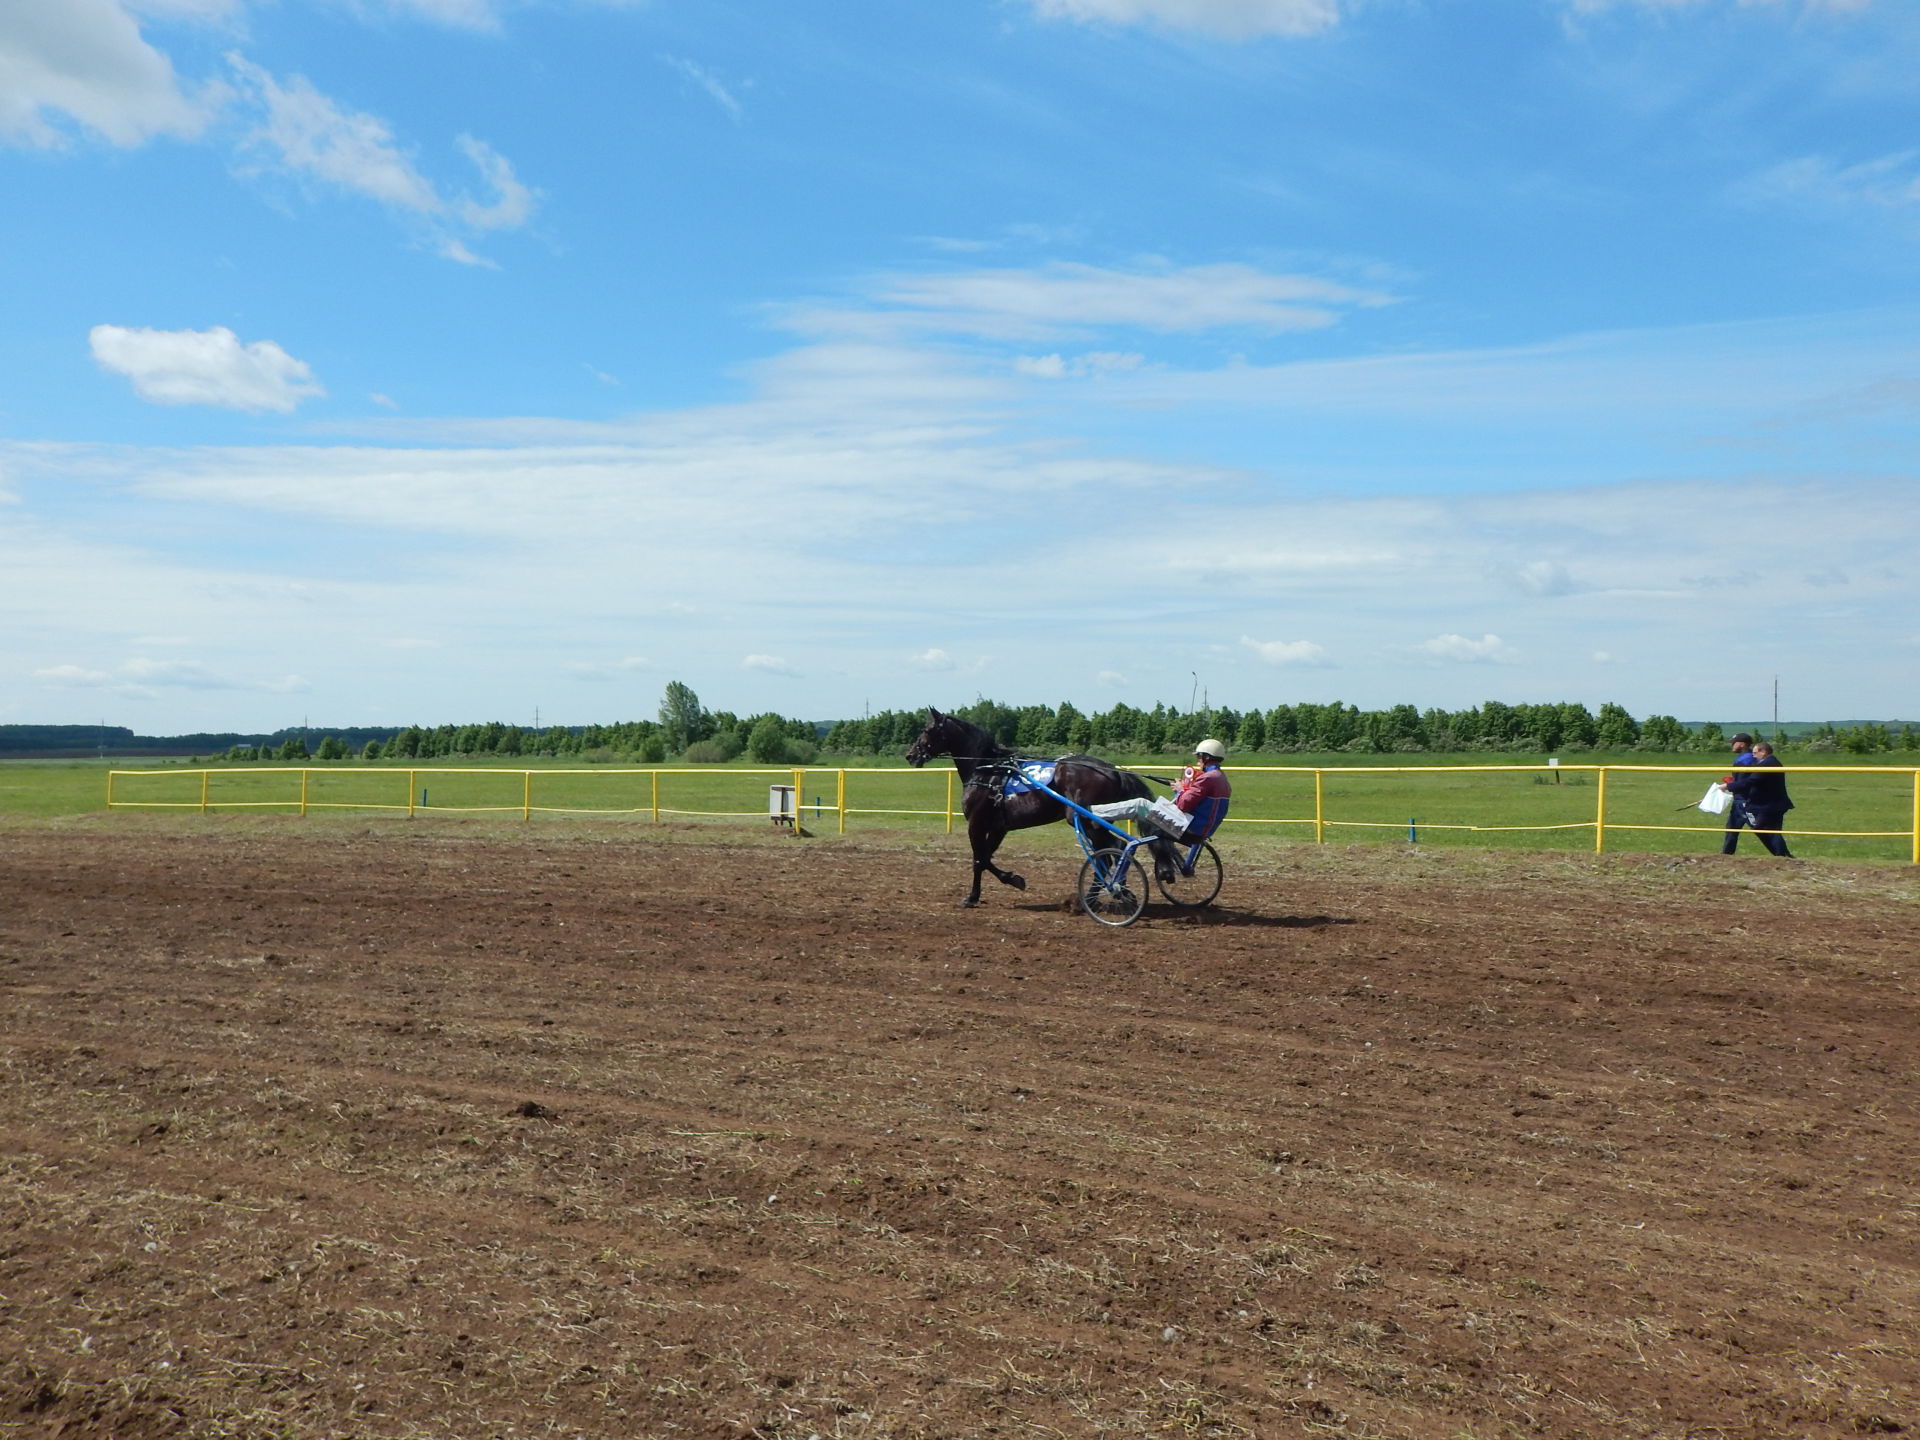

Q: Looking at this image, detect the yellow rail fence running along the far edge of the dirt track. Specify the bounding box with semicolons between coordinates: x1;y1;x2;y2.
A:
108;764;1920;866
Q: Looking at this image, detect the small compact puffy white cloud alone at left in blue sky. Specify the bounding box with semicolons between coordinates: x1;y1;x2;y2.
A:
88;324;326;415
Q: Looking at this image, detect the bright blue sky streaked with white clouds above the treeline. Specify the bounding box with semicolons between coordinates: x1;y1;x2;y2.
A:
0;0;1920;733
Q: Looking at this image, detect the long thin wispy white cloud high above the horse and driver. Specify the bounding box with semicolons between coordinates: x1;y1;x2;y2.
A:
781;261;1392;345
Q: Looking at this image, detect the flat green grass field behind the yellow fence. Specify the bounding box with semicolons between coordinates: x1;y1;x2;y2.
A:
0;755;1916;862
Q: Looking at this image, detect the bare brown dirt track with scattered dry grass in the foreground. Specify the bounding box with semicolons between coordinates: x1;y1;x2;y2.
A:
0;816;1920;1440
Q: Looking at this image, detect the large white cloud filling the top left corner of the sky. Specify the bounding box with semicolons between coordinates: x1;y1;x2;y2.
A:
0;0;225;146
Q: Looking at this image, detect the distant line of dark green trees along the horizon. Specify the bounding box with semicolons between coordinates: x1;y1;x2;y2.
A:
0;698;1920;764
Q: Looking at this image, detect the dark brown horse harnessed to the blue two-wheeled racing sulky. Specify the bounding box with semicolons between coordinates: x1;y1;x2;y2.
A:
906;708;1152;904
